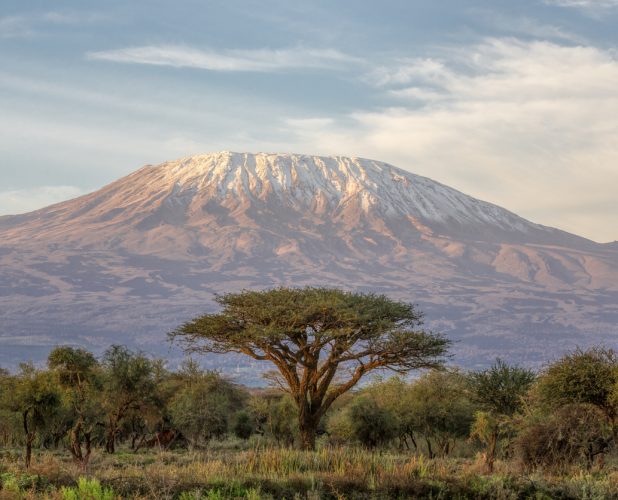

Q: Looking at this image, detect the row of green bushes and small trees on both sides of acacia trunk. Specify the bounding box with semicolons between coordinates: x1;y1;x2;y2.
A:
0;346;618;470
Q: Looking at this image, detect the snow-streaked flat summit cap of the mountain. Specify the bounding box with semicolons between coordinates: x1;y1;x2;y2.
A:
143;151;538;233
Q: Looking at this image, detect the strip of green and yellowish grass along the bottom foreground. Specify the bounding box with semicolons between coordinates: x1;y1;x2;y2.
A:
0;446;618;500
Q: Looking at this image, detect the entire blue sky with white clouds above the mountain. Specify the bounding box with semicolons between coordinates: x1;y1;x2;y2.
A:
0;0;618;242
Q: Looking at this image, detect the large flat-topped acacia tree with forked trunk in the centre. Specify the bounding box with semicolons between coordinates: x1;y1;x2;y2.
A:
170;287;450;449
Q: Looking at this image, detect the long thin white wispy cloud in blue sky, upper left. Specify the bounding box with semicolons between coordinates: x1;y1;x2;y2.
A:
87;45;360;72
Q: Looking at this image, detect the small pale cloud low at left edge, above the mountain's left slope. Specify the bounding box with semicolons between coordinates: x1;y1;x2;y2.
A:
0;186;85;215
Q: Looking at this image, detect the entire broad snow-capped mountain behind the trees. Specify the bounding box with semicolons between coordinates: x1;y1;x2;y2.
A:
0;152;618;373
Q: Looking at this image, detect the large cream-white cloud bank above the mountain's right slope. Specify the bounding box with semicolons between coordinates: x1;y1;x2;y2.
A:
290;39;618;240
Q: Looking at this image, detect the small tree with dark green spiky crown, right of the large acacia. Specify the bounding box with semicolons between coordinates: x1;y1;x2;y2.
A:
469;359;535;472
